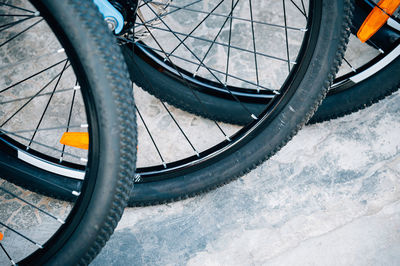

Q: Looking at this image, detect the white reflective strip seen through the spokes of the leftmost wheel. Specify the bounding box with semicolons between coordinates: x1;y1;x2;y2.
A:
18;150;85;180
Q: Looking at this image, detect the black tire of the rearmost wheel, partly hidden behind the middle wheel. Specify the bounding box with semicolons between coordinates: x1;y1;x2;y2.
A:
124;0;400;125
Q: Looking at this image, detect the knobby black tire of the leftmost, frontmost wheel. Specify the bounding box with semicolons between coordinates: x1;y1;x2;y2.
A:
0;0;136;265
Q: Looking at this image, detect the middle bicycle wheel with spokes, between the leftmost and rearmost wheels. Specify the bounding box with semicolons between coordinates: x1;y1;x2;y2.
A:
4;0;351;206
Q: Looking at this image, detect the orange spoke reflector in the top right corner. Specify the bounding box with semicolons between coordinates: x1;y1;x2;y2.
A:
357;0;400;42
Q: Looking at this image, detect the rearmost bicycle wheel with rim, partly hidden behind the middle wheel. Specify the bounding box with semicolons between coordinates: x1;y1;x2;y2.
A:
128;0;400;125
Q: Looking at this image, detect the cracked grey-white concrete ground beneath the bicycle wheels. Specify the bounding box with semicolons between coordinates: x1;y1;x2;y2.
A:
0;0;400;265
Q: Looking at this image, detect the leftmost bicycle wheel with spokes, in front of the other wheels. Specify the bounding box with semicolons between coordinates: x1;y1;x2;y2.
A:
0;0;136;265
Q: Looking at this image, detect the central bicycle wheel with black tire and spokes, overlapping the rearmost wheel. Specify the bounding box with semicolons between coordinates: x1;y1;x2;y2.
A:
120;1;351;205
